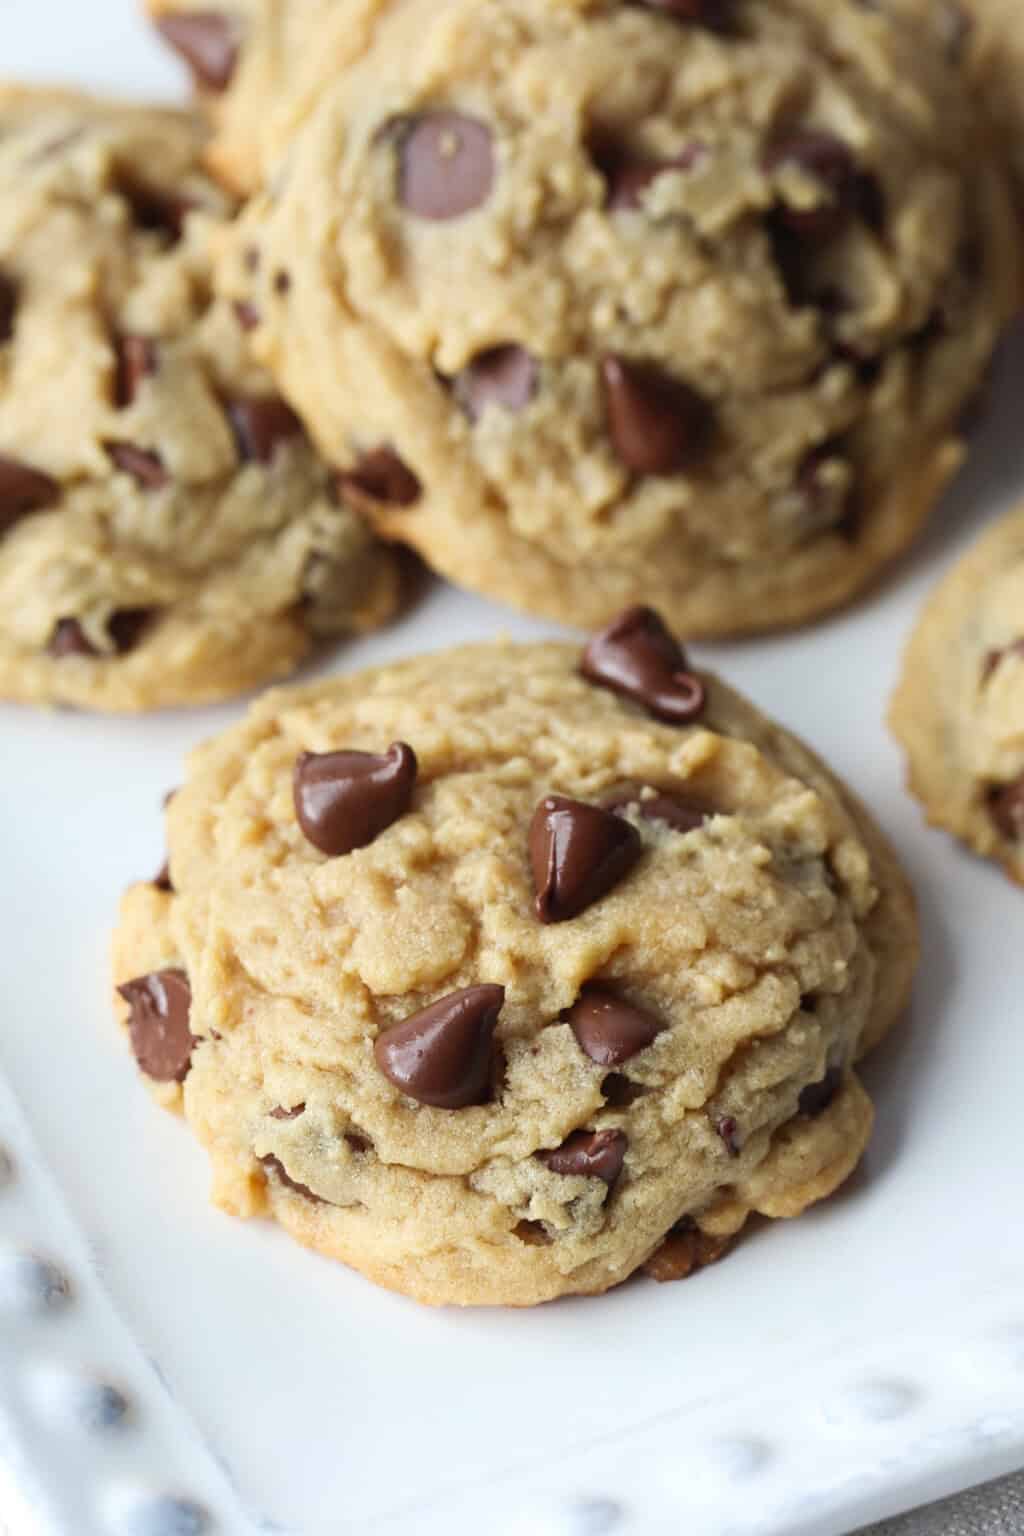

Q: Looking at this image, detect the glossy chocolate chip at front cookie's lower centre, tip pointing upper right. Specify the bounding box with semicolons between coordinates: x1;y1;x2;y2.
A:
373;986;505;1109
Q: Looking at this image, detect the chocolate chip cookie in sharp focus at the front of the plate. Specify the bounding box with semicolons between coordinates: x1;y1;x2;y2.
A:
114;610;917;1306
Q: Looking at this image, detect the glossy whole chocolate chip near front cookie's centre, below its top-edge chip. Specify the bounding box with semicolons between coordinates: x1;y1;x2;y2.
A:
528;794;643;923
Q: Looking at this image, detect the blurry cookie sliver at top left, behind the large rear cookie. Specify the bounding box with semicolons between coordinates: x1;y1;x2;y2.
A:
146;0;383;192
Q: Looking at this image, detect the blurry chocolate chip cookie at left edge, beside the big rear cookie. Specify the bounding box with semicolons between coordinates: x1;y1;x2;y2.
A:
0;89;396;710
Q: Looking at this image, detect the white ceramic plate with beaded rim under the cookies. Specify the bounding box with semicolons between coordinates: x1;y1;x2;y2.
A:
0;0;1024;1536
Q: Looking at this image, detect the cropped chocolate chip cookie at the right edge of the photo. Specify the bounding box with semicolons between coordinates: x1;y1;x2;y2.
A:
889;507;1024;882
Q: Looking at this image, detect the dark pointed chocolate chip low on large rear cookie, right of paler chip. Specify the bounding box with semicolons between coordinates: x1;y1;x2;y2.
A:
600;356;711;475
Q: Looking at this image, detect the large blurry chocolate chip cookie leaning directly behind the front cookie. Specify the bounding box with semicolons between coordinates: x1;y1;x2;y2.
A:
223;0;1016;634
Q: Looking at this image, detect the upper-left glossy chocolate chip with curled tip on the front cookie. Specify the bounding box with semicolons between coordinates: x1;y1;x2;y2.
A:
293;742;416;857
